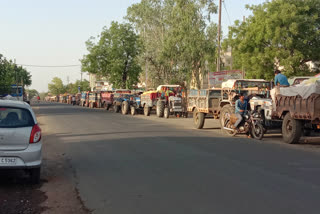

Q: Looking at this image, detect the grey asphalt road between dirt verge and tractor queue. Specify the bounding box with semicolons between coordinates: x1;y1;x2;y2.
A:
35;104;320;214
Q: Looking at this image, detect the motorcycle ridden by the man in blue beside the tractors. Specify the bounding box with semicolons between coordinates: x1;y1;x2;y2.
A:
223;111;265;140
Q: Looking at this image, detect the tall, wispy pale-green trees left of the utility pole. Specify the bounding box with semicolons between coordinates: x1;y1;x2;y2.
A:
126;0;217;88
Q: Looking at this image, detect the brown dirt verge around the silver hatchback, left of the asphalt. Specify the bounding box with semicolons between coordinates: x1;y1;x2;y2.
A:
0;109;90;214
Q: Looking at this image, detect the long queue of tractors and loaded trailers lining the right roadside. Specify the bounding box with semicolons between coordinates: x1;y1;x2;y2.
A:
53;79;320;143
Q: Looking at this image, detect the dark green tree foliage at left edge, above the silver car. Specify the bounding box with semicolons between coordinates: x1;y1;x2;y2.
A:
0;54;32;94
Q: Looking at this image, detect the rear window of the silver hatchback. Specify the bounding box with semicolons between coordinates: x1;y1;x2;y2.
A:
0;106;34;128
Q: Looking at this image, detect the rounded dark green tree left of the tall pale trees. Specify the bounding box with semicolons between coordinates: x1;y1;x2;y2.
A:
81;22;141;88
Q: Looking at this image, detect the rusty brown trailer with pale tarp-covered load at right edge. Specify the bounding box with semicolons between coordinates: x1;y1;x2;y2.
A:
250;77;320;144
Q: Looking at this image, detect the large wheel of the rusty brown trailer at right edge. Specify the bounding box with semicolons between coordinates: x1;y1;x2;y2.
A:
282;112;303;144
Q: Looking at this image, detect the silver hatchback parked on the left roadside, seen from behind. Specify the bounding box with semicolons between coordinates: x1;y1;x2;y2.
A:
0;100;42;183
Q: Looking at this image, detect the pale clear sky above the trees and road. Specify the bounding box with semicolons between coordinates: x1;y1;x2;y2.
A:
0;0;265;92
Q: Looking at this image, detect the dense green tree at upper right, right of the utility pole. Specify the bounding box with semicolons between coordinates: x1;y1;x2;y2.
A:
226;0;320;79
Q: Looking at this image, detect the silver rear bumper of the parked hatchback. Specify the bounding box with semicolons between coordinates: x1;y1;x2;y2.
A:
0;141;42;169
